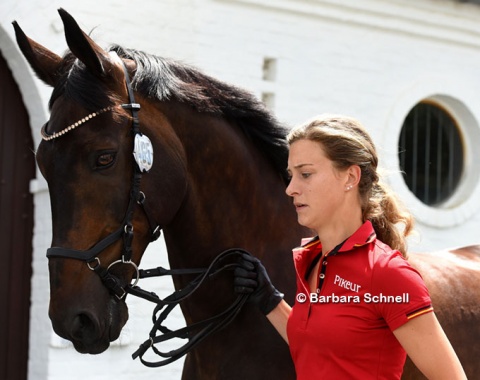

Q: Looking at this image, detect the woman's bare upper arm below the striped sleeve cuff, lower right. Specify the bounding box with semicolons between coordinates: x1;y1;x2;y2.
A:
393;313;467;380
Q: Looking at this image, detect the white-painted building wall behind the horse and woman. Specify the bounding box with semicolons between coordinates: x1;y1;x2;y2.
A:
0;0;480;380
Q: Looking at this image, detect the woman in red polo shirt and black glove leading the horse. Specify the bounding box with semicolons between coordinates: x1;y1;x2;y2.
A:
235;115;466;380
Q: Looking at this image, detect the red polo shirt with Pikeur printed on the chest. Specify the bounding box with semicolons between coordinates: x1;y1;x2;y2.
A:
287;221;433;380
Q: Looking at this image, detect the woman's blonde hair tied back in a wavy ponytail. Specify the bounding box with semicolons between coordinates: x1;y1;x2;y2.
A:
287;115;414;257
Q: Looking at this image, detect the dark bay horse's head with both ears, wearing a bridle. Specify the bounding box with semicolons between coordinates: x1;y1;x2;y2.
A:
14;9;185;353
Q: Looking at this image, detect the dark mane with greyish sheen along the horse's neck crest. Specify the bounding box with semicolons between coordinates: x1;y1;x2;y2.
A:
110;45;288;183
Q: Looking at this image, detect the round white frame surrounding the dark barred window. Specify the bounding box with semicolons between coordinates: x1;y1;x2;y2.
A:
380;87;480;228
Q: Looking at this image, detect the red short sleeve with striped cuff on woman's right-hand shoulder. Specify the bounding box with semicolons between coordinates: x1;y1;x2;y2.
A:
372;252;433;331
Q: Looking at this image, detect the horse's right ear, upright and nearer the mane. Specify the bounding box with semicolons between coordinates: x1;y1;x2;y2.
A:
58;8;111;77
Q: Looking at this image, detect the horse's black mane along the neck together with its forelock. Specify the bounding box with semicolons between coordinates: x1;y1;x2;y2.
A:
50;46;288;181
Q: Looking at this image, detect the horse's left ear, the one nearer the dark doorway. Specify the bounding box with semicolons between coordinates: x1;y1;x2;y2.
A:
12;21;62;86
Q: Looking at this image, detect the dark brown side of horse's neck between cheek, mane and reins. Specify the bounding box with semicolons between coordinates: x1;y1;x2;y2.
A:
156;104;301;267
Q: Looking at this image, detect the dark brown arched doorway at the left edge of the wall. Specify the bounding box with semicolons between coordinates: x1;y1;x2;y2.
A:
0;52;35;380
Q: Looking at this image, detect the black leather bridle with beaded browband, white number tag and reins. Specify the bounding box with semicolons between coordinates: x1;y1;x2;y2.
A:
41;52;248;367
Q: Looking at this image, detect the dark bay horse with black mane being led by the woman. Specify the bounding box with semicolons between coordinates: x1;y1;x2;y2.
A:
14;10;480;380
